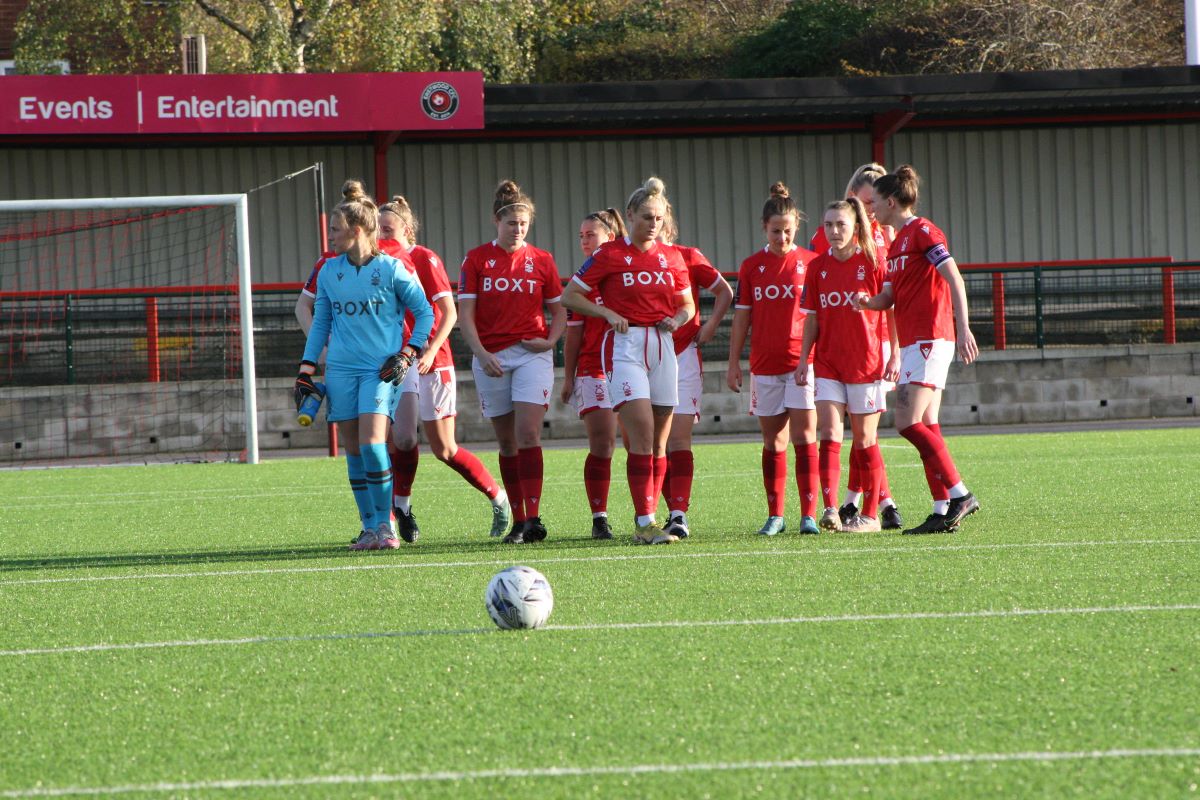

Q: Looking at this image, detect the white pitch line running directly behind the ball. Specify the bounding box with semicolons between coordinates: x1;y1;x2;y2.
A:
0;603;1200;657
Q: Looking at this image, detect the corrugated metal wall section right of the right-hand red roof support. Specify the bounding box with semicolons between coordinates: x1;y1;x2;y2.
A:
888;124;1200;261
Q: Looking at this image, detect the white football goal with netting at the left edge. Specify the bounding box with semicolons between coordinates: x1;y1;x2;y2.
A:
0;193;259;464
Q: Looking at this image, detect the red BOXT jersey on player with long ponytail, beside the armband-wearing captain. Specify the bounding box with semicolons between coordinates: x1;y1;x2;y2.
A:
800;248;883;384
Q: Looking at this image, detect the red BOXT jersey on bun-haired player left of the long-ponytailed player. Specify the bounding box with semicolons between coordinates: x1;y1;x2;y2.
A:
733;247;816;375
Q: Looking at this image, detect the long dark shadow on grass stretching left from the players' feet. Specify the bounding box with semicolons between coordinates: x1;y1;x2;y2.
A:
0;536;625;575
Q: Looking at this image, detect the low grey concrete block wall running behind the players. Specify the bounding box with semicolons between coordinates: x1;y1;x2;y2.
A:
0;344;1200;464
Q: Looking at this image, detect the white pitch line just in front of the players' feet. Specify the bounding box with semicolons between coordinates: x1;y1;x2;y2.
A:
0;539;1200;589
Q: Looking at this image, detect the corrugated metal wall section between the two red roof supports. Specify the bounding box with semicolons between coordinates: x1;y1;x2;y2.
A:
389;134;870;275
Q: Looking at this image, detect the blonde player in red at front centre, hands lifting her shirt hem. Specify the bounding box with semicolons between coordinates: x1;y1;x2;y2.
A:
563;178;695;545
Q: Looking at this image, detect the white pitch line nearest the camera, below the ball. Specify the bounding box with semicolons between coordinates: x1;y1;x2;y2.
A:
0;747;1200;798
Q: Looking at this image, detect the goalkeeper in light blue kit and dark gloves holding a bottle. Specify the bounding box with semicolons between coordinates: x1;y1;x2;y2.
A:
295;181;433;551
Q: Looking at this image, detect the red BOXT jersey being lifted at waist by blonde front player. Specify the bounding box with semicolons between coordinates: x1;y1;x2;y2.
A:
571;239;691;327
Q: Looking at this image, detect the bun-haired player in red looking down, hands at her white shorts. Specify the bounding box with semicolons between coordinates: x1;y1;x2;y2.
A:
458;180;566;545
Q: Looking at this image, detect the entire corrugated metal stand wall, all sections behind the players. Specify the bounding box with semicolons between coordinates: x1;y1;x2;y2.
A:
0;124;1200;288
